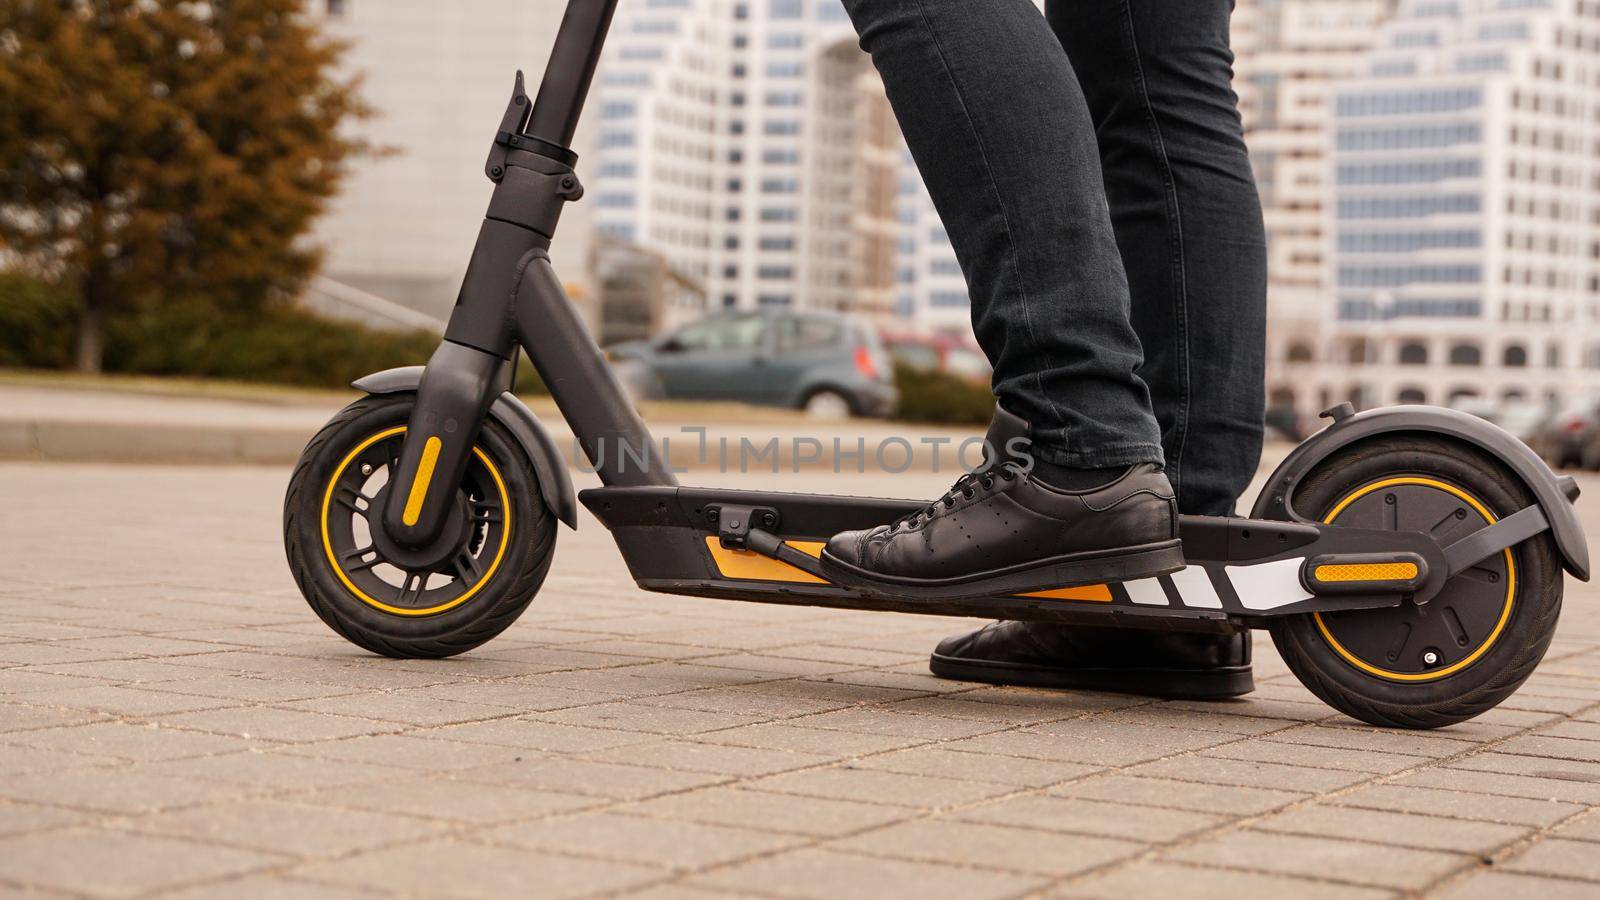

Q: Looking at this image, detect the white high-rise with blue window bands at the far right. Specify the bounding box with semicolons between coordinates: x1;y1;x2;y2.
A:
1275;0;1600;407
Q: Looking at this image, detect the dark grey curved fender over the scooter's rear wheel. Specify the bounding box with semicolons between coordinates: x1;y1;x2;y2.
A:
1251;407;1589;581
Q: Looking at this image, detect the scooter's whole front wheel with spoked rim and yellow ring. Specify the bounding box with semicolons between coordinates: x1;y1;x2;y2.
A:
283;394;555;658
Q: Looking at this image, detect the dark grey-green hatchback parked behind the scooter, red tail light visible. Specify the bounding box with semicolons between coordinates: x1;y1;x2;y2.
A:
608;311;899;418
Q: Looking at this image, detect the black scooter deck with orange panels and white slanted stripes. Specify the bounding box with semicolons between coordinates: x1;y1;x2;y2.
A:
579;485;1437;631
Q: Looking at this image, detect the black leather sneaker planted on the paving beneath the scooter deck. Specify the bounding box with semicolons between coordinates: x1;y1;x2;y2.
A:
928;621;1256;700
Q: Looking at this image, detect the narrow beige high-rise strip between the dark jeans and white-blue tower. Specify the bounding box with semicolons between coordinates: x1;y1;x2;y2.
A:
1232;0;1395;413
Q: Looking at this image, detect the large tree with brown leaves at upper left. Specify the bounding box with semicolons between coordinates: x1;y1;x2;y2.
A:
0;0;366;372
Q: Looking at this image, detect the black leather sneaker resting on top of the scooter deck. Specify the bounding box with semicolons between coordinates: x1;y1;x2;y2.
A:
822;408;1184;601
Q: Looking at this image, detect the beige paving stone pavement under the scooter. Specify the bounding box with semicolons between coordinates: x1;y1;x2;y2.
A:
0;463;1600;900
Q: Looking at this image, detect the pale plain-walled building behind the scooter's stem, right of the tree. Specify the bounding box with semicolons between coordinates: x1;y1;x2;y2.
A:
306;0;597;319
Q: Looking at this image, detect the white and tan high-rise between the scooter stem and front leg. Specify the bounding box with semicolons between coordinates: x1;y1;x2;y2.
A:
590;0;899;319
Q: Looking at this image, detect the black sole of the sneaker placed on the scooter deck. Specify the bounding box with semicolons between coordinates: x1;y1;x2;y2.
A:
821;538;1184;601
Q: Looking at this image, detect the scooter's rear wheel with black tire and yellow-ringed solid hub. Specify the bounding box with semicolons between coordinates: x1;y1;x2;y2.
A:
1270;434;1562;729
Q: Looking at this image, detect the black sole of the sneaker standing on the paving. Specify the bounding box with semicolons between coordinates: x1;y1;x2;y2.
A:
928;653;1256;700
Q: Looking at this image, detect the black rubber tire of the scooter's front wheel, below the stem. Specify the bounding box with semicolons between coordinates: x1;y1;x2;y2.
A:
283;394;555;658
